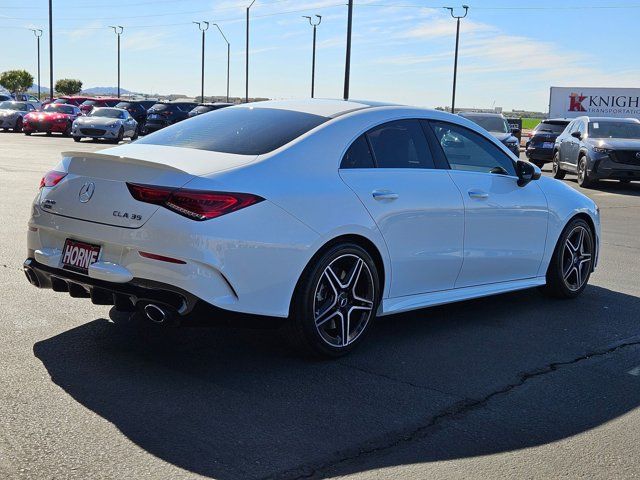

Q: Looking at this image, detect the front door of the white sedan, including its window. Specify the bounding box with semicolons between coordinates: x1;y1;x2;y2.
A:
429;121;548;288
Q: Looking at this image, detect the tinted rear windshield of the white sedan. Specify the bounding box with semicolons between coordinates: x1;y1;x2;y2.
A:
137;107;329;155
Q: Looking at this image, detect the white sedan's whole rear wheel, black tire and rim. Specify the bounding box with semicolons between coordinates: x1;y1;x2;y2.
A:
284;243;381;358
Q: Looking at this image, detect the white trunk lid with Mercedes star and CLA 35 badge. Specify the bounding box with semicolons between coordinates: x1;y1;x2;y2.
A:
39;144;255;228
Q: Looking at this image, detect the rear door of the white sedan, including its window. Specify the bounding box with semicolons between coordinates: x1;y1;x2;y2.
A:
340;119;464;297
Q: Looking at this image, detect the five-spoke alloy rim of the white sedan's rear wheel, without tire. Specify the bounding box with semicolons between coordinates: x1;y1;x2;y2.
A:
313;254;376;348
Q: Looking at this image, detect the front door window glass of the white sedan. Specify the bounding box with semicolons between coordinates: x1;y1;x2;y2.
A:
430;122;516;176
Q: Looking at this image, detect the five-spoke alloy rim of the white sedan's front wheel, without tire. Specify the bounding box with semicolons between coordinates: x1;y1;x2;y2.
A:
562;225;593;292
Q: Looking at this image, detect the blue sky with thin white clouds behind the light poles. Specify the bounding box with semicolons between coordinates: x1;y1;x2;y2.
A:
0;0;640;111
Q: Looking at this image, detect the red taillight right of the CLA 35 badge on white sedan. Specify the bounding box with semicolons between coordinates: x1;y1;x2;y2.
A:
127;183;264;221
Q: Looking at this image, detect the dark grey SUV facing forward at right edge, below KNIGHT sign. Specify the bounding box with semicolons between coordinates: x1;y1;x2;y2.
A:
553;117;640;188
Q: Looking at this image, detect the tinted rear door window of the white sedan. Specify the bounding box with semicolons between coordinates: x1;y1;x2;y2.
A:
366;120;435;168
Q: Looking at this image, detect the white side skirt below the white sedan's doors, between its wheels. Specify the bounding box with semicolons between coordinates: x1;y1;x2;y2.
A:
378;276;546;316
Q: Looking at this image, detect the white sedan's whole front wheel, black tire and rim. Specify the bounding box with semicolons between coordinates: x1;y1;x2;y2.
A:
543;218;595;298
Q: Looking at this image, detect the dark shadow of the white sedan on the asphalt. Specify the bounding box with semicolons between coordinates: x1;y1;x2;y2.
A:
34;286;640;479
